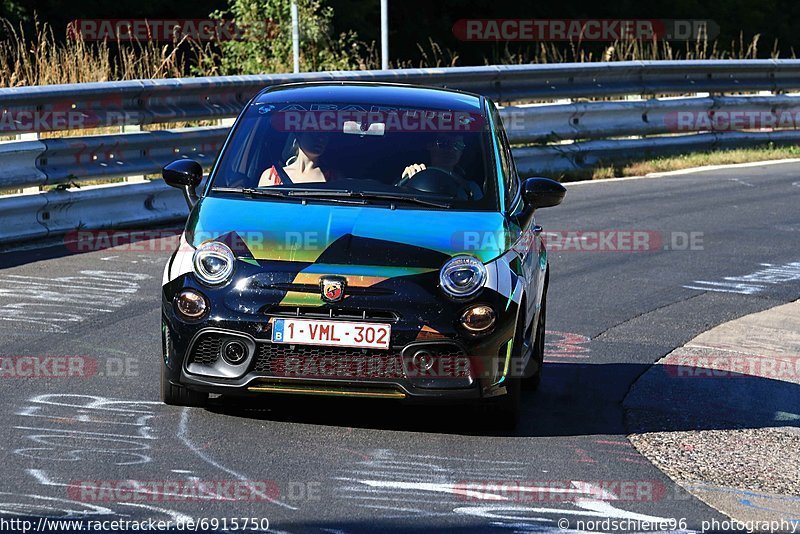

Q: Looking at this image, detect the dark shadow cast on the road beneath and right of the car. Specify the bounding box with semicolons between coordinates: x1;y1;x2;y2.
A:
202;363;800;436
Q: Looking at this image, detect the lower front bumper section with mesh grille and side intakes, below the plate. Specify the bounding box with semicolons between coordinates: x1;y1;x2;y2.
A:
165;327;504;400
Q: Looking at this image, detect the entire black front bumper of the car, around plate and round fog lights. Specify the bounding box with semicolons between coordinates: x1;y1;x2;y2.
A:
162;275;518;402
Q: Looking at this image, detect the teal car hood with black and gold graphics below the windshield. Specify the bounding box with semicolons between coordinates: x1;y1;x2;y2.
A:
186;197;519;269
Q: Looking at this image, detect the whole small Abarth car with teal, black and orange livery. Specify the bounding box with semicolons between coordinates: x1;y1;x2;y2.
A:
161;83;565;425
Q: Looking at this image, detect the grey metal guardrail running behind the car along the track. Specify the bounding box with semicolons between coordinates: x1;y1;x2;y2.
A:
0;60;800;247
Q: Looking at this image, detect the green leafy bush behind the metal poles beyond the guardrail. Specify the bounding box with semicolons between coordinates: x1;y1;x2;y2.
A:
197;0;376;75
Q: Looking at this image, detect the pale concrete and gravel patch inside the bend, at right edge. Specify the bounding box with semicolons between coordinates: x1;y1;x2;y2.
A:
623;300;800;532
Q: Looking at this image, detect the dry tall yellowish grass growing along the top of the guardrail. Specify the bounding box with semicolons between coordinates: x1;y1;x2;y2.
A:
0;20;794;87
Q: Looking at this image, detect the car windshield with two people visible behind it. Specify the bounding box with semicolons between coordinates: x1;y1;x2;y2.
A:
211;102;498;211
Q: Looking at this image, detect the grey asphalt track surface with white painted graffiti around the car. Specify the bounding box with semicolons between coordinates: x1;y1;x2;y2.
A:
0;164;800;532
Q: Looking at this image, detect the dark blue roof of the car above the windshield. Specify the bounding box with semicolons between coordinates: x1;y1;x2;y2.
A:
253;82;484;115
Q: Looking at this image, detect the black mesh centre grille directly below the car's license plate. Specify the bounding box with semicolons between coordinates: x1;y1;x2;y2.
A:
252;343;404;379
